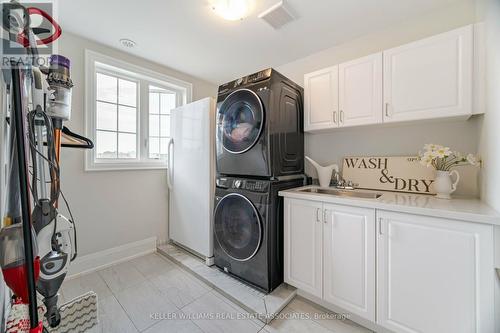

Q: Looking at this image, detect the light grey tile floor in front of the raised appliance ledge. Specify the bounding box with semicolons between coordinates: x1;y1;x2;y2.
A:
61;254;370;333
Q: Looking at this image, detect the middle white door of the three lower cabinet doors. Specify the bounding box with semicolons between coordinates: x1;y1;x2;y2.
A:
323;204;375;321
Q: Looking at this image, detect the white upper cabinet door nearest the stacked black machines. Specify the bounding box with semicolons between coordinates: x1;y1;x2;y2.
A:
304;66;339;132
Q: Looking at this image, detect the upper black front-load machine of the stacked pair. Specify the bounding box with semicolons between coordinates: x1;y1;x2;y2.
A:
216;68;304;178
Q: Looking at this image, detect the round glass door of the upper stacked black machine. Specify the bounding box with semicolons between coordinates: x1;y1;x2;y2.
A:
218;89;264;154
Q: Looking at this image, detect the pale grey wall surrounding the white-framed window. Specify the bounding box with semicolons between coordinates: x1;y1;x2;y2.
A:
59;32;217;255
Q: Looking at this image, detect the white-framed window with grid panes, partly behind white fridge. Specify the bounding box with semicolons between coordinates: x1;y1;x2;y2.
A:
85;51;192;170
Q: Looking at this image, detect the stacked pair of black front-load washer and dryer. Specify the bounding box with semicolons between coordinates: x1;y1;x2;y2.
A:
214;68;305;292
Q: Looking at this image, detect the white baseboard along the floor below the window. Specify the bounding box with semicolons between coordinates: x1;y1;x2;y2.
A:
67;237;156;279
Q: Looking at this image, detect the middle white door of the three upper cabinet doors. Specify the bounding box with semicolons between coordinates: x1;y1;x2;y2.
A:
339;53;382;126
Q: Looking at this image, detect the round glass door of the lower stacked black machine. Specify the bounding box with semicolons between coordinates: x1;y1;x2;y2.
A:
214;193;262;261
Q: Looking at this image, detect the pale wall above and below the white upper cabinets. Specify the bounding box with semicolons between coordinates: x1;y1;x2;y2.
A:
276;0;480;195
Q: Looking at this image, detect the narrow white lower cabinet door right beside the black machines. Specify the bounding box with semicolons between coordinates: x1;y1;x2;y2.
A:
284;198;323;297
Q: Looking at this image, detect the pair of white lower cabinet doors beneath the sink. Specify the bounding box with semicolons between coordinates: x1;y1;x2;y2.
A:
284;198;375;320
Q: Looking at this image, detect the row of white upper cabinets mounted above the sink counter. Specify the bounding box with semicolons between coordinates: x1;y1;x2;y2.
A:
304;25;478;132
